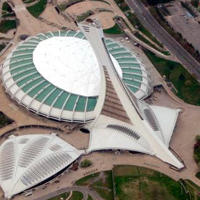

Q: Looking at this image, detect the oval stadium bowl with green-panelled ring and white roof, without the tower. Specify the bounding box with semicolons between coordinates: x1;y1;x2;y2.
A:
2;30;152;123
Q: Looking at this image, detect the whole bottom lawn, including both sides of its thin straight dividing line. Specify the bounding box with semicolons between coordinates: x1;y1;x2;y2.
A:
76;165;200;200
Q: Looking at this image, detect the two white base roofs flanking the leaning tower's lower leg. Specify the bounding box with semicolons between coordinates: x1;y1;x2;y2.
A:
87;106;180;155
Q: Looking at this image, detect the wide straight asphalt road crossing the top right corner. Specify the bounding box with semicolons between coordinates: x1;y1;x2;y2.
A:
127;0;200;82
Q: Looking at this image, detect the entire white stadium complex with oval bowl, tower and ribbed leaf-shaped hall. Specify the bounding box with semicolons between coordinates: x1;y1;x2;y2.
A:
0;20;184;198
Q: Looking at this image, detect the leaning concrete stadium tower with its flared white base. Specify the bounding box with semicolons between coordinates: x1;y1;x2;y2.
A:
79;20;184;169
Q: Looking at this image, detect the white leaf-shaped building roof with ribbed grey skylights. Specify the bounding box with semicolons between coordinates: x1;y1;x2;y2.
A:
0;134;82;198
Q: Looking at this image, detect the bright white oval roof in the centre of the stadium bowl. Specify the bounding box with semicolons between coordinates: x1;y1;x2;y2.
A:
33;37;122;96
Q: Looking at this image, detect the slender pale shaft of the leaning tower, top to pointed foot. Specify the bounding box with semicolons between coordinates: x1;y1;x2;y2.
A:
79;21;184;169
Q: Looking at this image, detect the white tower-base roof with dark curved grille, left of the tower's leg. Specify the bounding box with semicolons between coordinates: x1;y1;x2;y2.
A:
87;119;154;155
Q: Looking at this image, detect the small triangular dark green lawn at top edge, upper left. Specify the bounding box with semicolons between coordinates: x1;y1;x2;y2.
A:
27;0;47;18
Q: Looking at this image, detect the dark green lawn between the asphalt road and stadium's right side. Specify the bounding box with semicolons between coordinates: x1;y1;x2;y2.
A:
144;50;200;105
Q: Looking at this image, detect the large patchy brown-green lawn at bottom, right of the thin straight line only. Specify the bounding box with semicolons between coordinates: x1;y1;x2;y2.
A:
113;166;188;200
